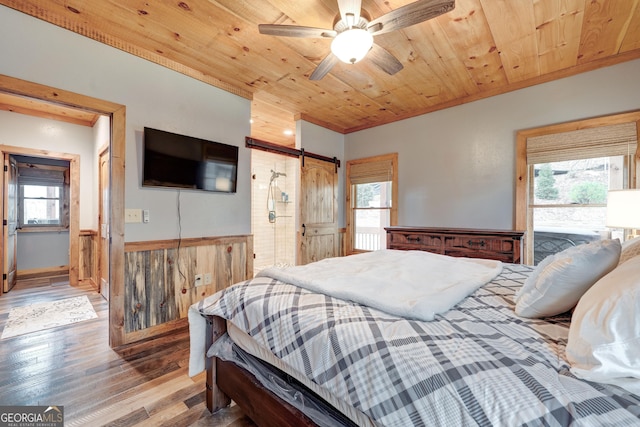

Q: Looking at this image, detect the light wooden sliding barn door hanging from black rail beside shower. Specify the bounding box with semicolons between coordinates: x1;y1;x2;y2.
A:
298;157;340;264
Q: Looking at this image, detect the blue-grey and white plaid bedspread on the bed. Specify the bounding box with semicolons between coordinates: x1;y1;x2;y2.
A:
197;264;640;427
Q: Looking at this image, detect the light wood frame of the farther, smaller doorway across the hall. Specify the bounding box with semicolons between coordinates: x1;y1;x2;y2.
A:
0;145;80;286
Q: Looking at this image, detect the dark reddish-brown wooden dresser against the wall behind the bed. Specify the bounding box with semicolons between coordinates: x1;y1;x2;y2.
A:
385;226;524;264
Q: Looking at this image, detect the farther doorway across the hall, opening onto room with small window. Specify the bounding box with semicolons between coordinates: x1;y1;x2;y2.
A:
0;145;80;292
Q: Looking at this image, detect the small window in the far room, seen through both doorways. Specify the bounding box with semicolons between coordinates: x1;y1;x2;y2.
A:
18;163;69;230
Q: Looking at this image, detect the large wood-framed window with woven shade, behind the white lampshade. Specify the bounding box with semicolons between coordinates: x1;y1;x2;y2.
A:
516;114;640;265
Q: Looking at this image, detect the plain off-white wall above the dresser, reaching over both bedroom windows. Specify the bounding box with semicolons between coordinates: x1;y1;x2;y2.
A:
345;60;640;229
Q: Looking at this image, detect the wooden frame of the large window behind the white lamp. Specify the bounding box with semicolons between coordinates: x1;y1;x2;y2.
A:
514;111;640;265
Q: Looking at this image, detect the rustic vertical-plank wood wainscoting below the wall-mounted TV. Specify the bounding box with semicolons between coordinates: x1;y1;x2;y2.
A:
124;235;253;342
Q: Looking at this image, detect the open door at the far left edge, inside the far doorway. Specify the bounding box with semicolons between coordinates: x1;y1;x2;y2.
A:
2;154;18;292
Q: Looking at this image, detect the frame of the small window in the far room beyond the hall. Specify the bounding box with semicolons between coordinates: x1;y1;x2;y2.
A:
18;163;70;233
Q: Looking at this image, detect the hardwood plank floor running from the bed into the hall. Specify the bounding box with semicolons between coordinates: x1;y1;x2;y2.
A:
0;277;255;427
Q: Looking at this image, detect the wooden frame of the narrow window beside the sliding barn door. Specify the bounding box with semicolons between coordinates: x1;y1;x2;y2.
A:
345;153;398;255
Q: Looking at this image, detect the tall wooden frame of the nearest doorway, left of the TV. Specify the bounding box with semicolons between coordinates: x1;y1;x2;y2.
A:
0;74;126;347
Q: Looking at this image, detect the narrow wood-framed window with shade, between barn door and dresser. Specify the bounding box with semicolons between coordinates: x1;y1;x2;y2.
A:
347;154;398;254
